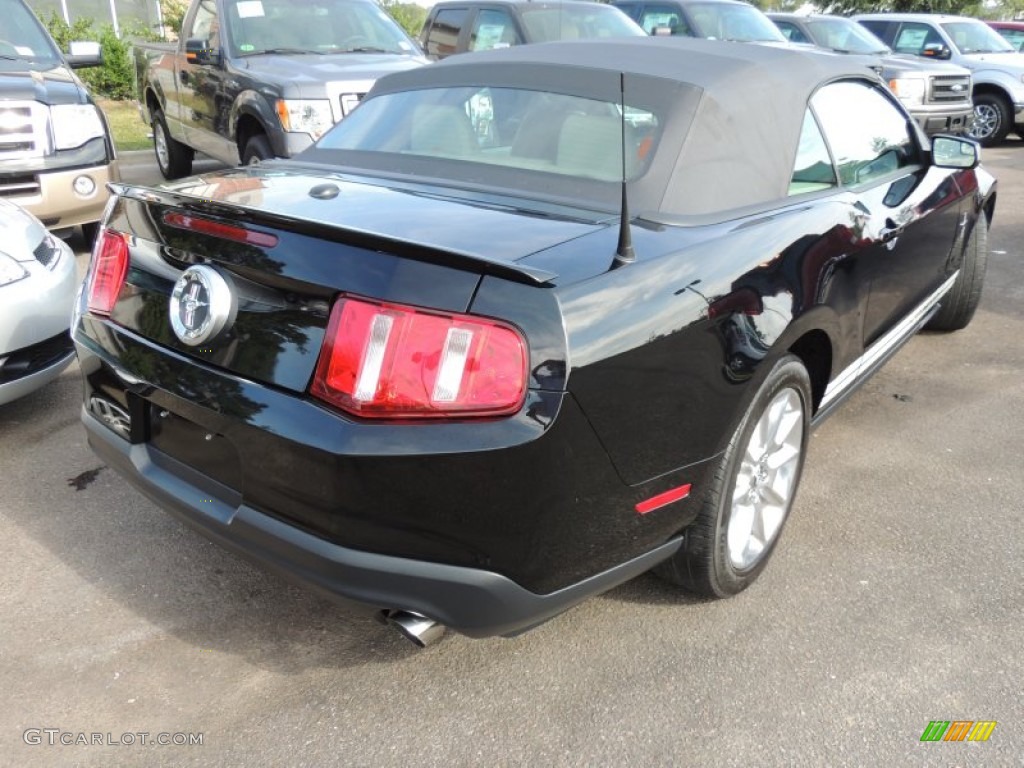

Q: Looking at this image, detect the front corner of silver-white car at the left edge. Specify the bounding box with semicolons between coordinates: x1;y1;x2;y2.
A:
0;199;79;406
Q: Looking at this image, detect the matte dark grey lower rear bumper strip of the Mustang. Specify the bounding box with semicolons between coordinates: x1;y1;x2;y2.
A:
82;408;681;637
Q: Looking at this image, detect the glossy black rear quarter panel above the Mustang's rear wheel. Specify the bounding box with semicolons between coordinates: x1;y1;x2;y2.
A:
559;201;868;483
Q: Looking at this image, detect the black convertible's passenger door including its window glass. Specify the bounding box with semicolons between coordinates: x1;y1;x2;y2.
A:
811;81;961;347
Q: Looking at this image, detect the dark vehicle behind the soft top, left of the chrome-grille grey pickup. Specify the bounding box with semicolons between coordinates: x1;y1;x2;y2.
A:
612;0;786;44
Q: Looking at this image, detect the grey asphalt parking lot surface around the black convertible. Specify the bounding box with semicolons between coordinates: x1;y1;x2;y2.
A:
0;139;1024;766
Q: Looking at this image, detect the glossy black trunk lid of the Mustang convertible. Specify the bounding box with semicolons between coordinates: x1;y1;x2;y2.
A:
100;172;603;391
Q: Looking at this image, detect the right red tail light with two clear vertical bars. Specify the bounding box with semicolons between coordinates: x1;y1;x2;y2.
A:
310;298;526;419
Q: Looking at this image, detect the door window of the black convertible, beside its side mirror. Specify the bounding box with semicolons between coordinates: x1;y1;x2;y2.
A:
811;81;919;184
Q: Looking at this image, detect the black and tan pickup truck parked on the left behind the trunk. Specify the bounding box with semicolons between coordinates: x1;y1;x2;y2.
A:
135;0;427;179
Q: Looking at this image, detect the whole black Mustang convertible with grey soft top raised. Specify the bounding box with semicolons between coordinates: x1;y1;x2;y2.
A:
74;38;996;642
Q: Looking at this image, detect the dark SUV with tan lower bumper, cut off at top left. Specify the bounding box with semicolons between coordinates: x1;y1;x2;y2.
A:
0;0;120;243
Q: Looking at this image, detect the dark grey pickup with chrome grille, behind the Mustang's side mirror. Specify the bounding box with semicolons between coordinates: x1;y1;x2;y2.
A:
768;13;974;134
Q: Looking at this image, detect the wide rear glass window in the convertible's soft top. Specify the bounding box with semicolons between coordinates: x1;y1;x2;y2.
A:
316;86;664;186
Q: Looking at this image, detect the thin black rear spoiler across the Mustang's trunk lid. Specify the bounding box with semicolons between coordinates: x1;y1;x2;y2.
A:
108;183;558;286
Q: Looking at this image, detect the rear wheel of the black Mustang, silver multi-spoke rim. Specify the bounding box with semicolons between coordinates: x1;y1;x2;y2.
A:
655;354;811;598
